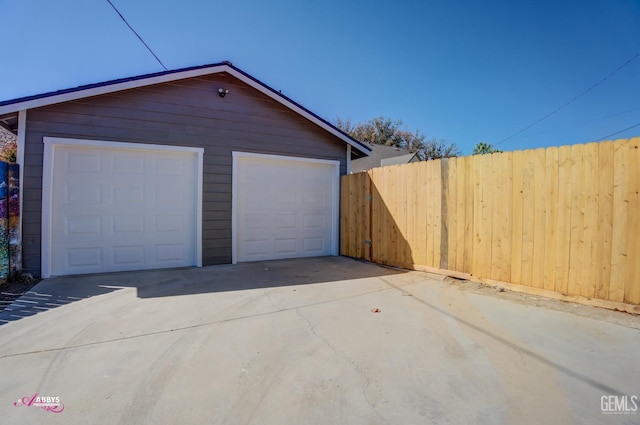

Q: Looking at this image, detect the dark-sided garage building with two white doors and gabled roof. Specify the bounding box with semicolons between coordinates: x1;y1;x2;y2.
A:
0;62;370;277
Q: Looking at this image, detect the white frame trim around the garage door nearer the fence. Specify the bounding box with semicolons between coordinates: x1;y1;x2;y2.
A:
231;151;340;264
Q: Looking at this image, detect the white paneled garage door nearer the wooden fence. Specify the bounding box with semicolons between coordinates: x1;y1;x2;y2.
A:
233;152;339;262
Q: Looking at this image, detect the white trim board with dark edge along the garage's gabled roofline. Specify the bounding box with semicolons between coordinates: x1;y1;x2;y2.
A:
0;62;371;155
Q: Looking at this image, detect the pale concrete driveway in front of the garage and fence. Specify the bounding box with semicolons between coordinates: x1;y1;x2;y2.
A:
0;257;640;425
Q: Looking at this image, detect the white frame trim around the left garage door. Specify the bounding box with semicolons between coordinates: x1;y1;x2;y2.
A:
40;137;204;278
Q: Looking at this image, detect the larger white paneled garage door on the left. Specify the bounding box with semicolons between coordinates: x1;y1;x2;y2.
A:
45;139;199;275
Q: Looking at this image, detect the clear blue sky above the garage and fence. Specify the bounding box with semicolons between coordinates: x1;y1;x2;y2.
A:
0;0;640;154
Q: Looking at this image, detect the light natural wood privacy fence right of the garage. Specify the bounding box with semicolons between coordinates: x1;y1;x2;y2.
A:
341;138;640;305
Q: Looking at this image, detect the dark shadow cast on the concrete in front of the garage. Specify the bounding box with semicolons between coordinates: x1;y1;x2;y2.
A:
0;257;403;326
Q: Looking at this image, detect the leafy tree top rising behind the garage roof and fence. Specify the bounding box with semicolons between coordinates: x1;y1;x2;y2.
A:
335;117;460;160
